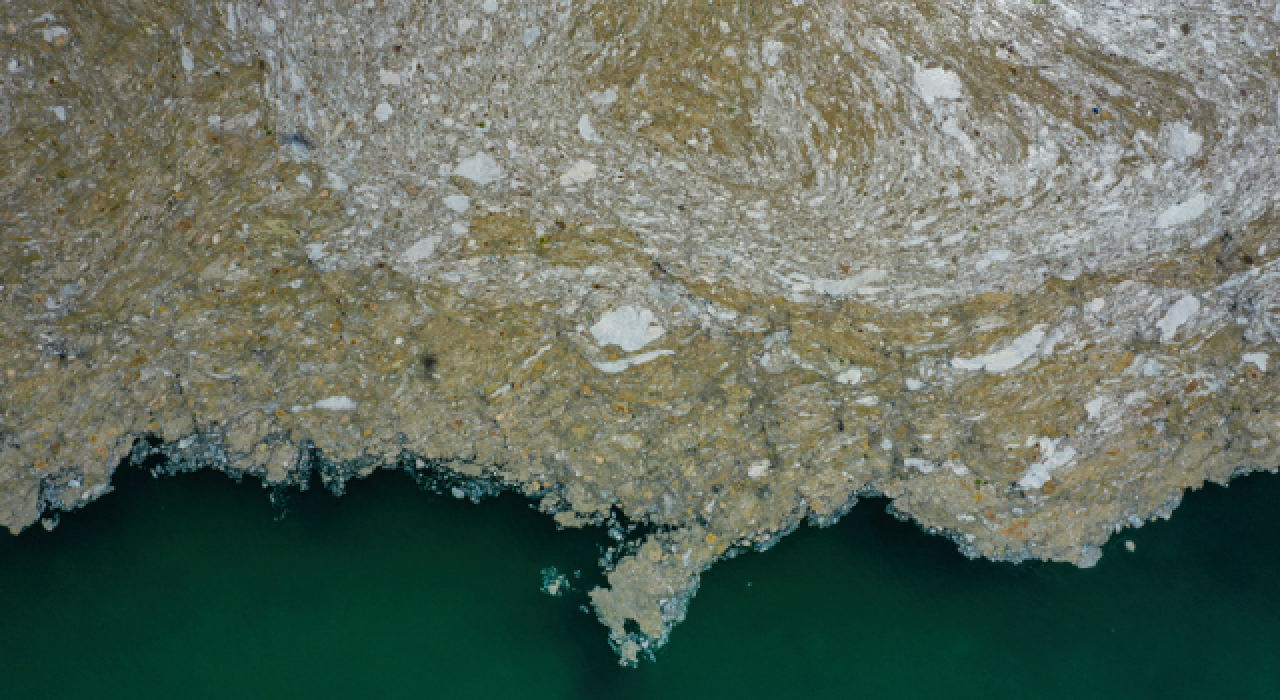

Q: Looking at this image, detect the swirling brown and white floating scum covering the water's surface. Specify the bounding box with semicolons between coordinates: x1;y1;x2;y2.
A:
0;0;1280;662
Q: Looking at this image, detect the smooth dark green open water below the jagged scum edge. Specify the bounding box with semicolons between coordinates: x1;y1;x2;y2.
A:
0;467;1280;700
